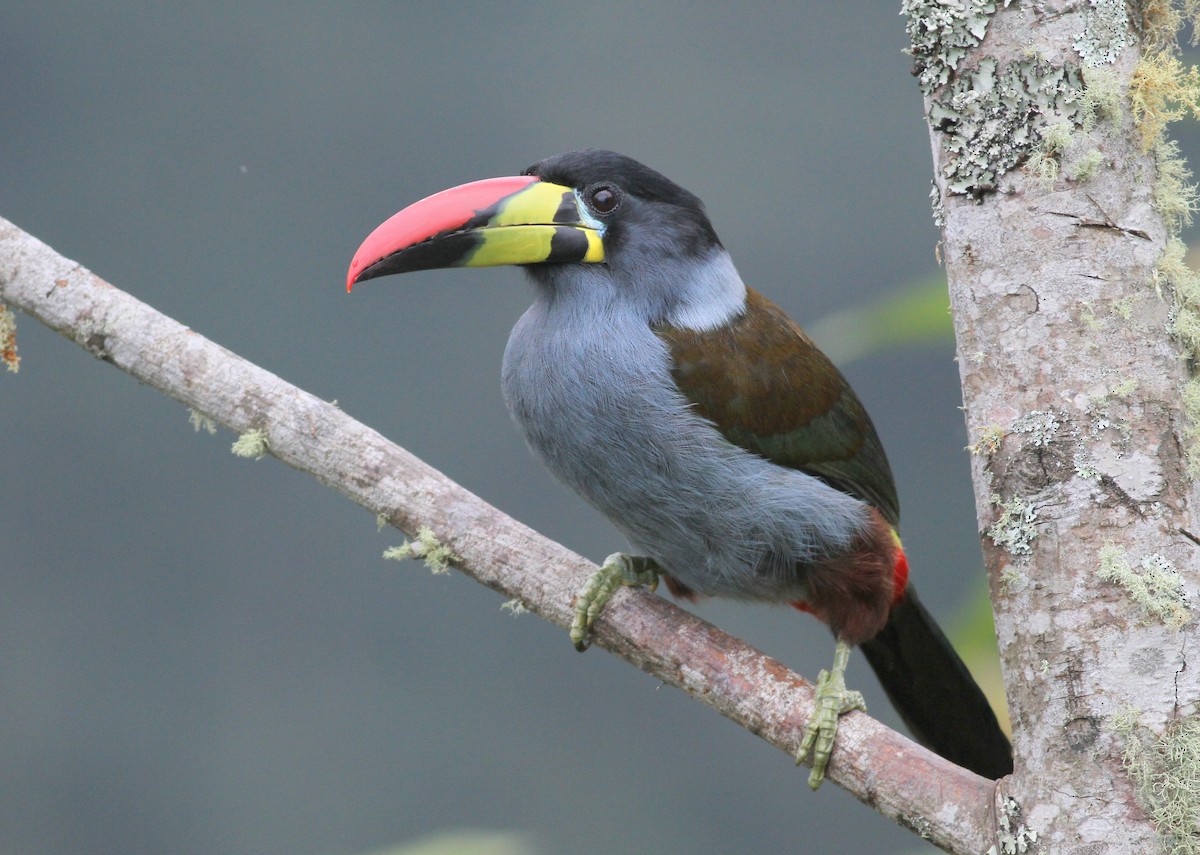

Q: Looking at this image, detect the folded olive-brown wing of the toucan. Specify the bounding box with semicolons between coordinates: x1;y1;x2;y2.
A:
655;289;900;527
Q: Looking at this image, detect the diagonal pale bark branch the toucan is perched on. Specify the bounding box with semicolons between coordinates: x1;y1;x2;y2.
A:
0;219;996;853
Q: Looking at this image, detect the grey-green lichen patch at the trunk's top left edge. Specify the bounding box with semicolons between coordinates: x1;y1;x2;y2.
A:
900;0;1009;95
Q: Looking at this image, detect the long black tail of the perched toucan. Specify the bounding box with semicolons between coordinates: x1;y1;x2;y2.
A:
859;585;1013;779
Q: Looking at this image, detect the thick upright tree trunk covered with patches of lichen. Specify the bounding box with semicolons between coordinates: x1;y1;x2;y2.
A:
904;0;1200;855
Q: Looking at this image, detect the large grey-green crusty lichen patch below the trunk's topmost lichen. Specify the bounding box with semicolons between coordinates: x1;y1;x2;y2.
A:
929;56;1084;198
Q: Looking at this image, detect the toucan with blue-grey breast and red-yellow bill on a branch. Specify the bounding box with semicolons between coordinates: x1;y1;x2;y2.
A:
347;149;1013;787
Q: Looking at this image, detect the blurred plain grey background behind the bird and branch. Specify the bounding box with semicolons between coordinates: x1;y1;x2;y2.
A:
0;0;1113;855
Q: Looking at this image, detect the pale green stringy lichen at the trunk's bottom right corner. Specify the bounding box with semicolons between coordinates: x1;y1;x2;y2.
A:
1112;708;1200;855
